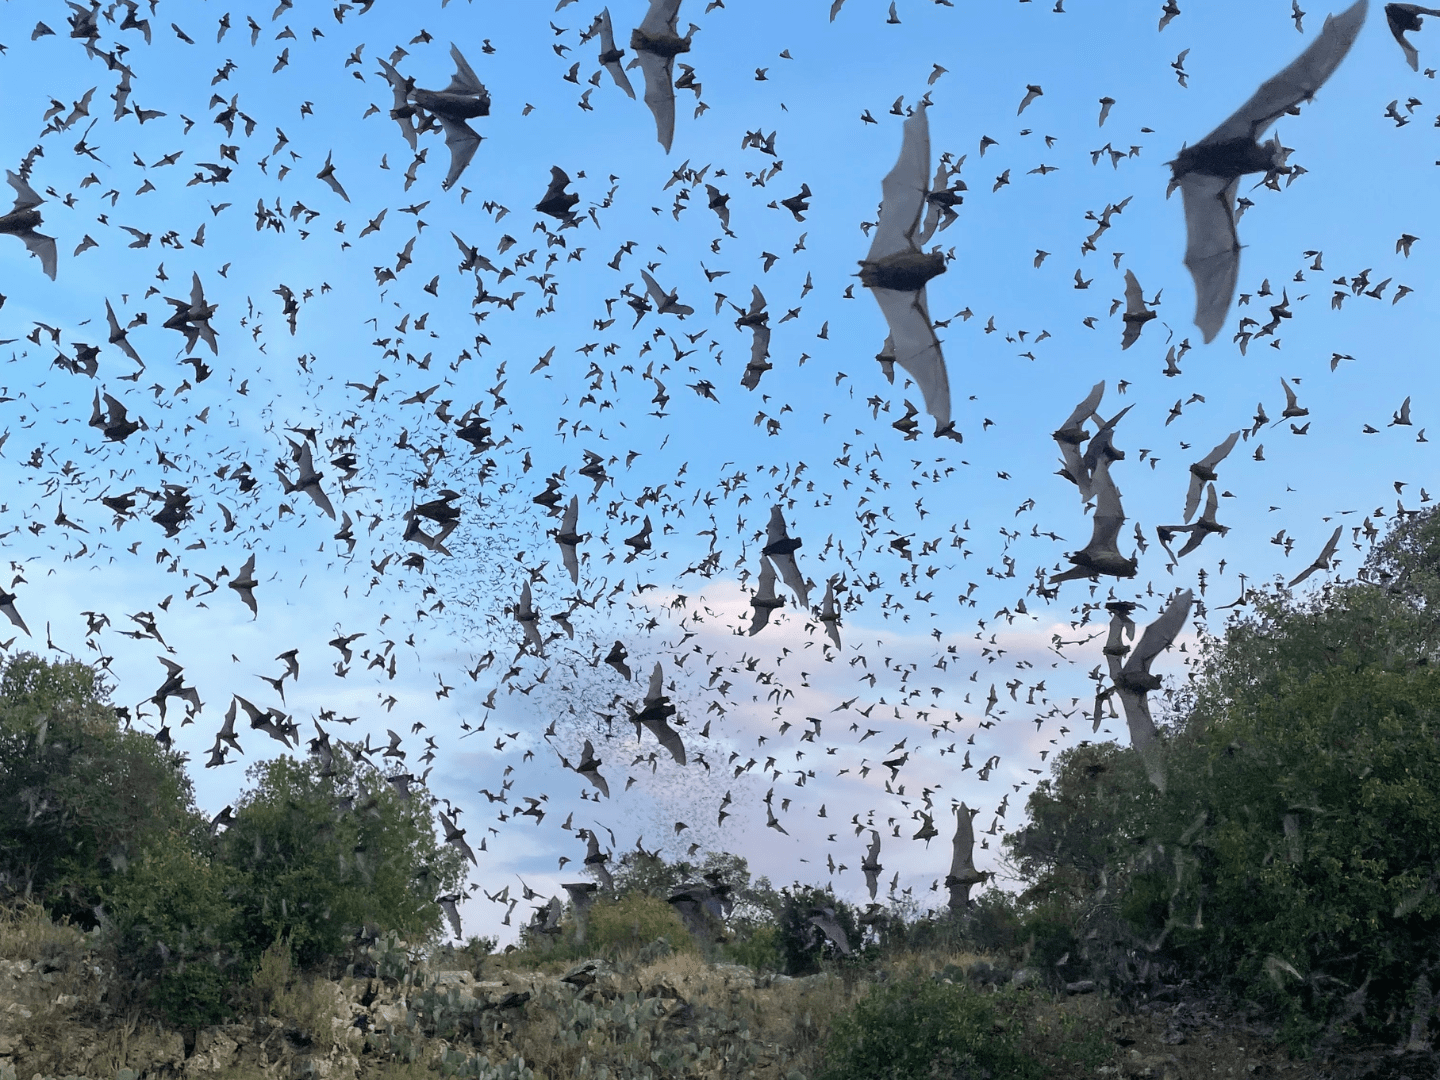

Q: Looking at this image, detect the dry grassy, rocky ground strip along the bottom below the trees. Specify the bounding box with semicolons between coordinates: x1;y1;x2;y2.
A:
0;935;1440;1080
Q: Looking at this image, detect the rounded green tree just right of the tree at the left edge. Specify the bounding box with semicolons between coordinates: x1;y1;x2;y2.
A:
217;752;465;968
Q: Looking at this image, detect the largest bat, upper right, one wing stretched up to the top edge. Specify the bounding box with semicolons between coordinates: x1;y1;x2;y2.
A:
1169;0;1368;343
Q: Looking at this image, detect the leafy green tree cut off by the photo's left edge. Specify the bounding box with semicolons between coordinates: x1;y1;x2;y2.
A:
0;654;204;926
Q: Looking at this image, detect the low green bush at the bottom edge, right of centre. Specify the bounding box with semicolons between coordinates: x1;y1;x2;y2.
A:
816;973;1043;1080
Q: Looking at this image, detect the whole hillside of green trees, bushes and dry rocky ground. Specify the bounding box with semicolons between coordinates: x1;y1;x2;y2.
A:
8;514;1440;1080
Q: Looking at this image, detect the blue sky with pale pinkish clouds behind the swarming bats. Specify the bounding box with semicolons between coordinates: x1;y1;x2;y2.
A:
0;0;1436;939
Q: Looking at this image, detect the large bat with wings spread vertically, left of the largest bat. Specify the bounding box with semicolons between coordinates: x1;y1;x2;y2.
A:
860;102;955;435
